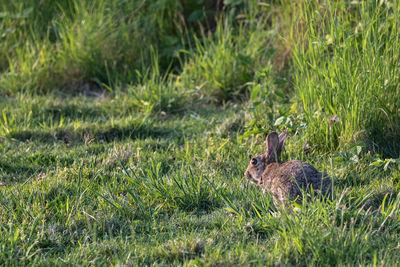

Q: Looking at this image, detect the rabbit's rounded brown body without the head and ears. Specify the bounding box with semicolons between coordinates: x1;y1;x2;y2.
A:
259;160;331;206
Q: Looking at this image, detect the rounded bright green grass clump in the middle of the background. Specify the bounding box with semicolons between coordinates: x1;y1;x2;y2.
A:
179;16;272;100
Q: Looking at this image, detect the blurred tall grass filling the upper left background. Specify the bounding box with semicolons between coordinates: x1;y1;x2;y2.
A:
0;0;228;94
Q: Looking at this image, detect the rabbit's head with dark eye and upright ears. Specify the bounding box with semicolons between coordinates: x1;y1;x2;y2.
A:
244;129;287;184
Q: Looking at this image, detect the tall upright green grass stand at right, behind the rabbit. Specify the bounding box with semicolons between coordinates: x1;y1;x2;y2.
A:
291;1;400;156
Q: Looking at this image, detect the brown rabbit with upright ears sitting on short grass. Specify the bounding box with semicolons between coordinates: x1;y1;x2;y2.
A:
244;129;332;208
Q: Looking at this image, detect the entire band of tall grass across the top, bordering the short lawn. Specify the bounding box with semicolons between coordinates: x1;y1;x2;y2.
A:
0;0;400;148
